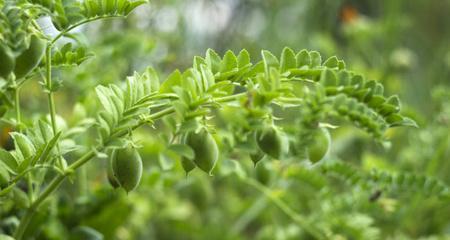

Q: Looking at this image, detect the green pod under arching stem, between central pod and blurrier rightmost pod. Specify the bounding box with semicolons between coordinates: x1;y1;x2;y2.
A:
255;127;283;159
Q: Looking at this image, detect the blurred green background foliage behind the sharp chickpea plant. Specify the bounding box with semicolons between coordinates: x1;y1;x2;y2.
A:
0;0;450;240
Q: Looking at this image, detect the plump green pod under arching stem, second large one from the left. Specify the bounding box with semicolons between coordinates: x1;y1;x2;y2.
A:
185;129;219;175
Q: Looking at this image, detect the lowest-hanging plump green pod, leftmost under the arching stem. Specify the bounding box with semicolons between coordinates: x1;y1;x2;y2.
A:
111;148;142;192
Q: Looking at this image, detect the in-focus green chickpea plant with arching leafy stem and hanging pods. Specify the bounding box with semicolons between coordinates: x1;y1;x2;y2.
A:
0;0;448;239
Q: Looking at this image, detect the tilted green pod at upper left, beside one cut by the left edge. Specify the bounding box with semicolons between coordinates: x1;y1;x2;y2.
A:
14;35;45;78
